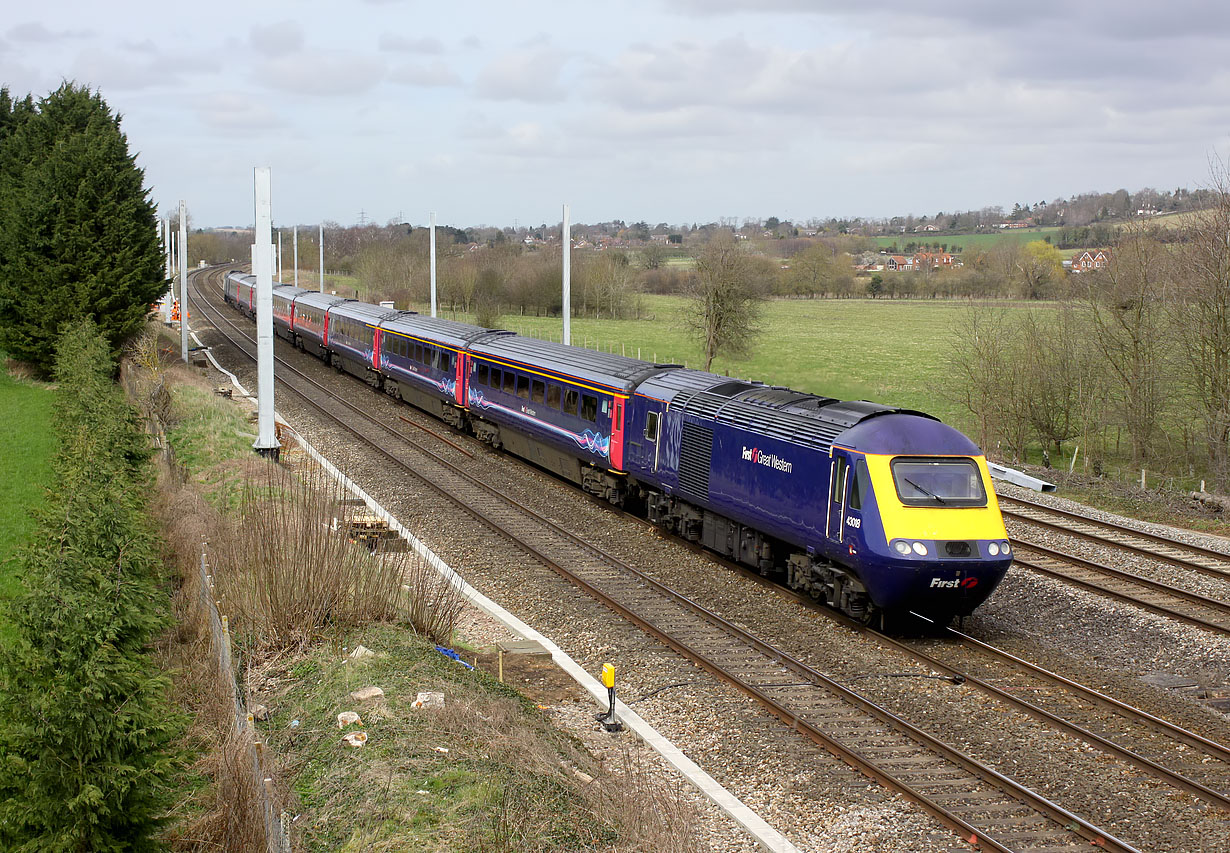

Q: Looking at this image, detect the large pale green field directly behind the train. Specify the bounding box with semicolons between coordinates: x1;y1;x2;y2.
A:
423;295;1038;427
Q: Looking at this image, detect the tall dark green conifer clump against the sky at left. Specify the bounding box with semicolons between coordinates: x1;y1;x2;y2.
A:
0;82;166;373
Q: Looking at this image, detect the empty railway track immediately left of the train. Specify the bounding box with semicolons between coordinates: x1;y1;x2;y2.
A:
186;270;1134;853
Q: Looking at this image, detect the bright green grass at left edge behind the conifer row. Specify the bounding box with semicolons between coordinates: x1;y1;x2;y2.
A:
0;373;55;638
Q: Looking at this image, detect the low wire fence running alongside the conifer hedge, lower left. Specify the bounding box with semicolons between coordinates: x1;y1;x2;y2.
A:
199;543;292;853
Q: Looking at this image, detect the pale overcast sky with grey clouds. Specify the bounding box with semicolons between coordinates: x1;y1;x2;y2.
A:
0;0;1230;225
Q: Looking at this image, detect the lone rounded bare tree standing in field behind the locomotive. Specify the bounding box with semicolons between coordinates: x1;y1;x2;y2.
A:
684;231;764;370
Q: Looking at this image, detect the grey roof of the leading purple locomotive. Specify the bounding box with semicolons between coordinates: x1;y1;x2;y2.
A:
654;370;939;453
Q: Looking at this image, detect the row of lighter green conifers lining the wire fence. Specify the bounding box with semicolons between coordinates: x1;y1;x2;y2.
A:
0;322;181;852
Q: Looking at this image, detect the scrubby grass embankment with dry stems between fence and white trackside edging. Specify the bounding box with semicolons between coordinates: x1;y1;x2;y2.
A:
152;347;695;852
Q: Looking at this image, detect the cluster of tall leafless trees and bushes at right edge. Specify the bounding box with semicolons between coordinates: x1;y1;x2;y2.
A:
951;180;1230;489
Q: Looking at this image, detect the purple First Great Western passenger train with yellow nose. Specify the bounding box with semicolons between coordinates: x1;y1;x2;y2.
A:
225;271;1012;624
